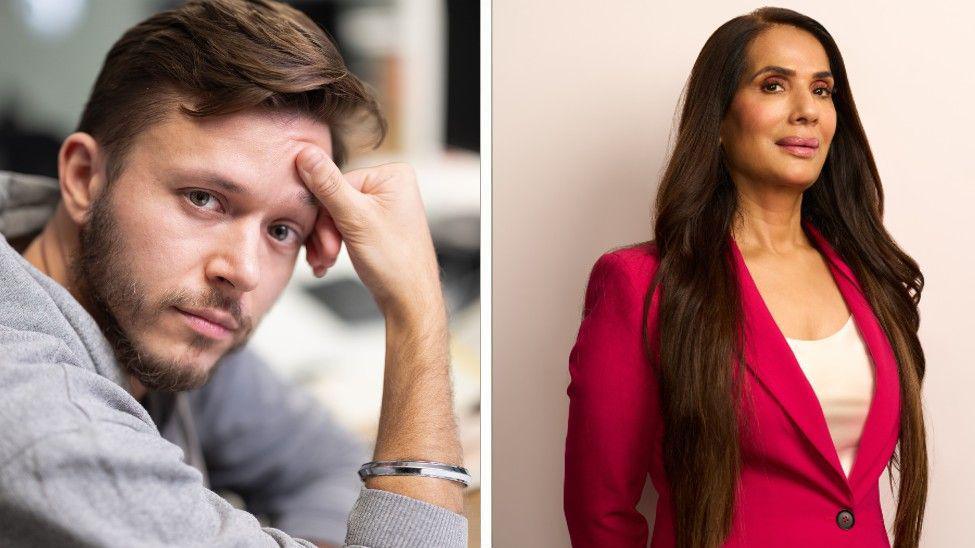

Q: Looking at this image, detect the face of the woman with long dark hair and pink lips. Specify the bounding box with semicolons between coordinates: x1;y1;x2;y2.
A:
720;25;836;192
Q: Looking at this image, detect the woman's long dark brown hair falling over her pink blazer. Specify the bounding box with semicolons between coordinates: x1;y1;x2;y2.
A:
644;7;928;548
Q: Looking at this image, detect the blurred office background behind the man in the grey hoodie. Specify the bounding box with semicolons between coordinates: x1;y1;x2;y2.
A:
0;0;480;545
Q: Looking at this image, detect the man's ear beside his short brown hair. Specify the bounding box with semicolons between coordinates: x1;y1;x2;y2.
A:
58;132;105;226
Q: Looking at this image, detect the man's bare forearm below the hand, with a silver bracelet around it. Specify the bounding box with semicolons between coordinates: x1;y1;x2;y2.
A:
366;292;463;514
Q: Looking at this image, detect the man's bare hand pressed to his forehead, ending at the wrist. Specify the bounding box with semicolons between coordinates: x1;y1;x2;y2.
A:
297;146;442;324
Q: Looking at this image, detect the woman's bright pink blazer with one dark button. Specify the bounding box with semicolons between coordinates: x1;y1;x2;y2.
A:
564;219;900;548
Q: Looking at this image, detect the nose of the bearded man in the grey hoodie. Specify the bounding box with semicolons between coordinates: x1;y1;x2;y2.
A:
206;223;261;292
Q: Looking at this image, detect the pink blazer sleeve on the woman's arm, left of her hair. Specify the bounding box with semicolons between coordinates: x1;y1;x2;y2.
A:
563;253;659;548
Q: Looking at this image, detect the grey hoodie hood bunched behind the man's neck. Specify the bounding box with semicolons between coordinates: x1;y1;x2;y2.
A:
0;171;61;240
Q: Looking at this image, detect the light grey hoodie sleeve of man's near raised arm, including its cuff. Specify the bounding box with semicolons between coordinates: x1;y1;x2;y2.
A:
0;340;467;548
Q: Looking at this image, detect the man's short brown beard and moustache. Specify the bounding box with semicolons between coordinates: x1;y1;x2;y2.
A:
71;185;253;392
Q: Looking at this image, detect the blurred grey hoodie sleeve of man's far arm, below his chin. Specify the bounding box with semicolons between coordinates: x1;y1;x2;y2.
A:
182;349;369;543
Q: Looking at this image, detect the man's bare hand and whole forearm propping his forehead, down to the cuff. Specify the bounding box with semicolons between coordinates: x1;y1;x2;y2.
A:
296;146;464;514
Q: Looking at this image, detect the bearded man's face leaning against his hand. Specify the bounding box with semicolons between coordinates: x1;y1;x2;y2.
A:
74;106;331;390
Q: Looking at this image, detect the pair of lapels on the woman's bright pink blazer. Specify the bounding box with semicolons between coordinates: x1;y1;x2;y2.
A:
729;221;899;496
